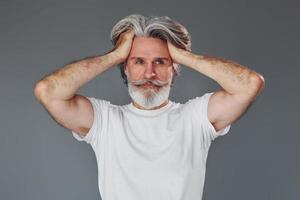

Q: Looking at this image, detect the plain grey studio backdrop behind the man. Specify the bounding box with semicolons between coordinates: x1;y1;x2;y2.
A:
0;0;300;200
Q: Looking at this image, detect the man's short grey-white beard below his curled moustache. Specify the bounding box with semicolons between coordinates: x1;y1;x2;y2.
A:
128;82;171;109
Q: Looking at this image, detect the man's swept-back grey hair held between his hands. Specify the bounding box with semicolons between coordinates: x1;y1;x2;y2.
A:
110;14;191;86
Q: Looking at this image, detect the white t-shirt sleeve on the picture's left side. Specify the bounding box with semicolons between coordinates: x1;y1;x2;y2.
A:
71;97;110;146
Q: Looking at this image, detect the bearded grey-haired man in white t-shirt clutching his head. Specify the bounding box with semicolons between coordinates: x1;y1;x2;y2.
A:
35;14;264;200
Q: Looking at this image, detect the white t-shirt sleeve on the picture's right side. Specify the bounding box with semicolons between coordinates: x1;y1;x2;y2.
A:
189;92;231;144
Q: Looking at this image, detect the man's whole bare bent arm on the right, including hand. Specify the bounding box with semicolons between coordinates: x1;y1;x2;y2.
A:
168;43;265;131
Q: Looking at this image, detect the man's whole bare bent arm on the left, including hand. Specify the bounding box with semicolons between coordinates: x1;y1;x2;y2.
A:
34;28;134;136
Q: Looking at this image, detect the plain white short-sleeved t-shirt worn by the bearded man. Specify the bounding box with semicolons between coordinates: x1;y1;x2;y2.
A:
72;92;231;200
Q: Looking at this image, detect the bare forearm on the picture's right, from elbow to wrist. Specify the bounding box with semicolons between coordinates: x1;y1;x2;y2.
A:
177;52;263;95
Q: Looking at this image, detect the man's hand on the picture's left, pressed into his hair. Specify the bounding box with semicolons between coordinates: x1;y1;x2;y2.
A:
112;29;135;63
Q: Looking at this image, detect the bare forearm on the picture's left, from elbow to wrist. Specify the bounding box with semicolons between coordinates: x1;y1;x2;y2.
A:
35;52;119;100
